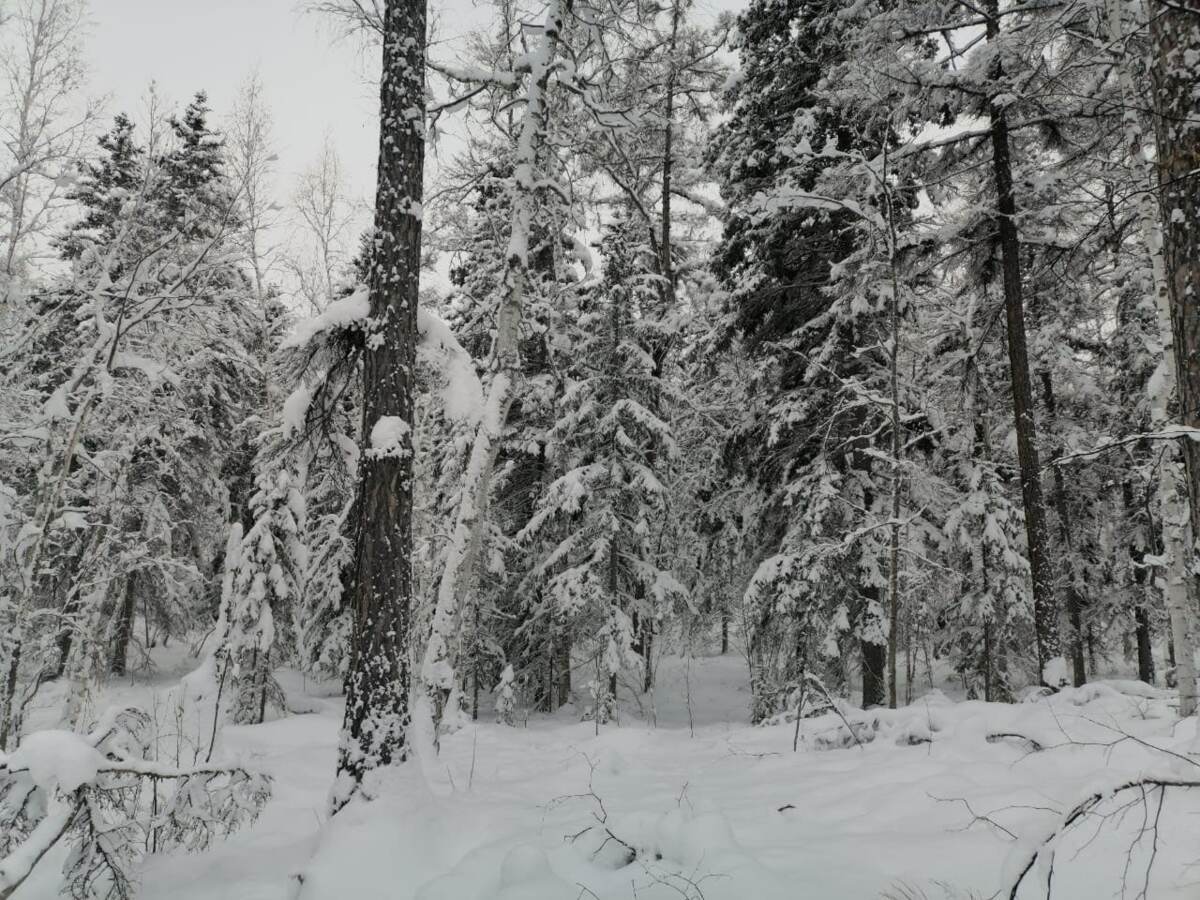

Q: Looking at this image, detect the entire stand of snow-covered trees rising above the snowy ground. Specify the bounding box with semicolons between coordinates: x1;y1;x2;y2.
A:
0;0;1200;806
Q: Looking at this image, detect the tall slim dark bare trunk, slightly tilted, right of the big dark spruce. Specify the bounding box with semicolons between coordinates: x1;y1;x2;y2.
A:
985;0;1058;680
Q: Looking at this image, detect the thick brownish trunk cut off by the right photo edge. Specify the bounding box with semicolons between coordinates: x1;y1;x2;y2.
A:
1151;0;1200;716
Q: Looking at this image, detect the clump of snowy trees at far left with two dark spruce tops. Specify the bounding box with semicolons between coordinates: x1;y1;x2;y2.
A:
0;95;265;743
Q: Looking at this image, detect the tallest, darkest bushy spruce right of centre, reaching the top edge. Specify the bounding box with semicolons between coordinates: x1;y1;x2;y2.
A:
712;0;893;706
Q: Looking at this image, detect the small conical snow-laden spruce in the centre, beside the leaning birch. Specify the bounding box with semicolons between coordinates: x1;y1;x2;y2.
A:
520;211;686;716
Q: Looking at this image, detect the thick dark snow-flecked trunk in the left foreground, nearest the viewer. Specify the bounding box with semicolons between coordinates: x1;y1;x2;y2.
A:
335;0;425;808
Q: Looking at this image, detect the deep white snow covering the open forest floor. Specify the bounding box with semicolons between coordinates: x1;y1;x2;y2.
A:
17;654;1200;900
